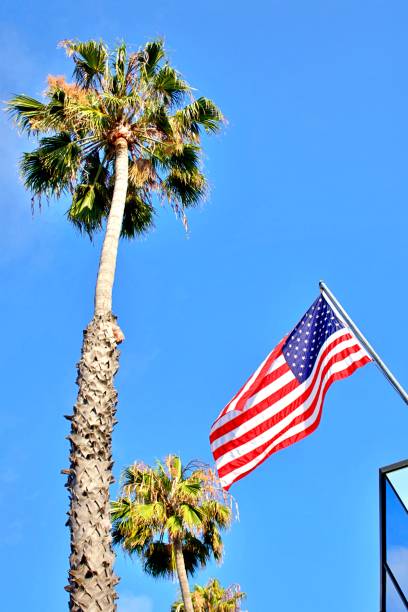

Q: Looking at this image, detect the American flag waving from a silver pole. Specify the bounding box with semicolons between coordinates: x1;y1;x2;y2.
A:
210;295;371;489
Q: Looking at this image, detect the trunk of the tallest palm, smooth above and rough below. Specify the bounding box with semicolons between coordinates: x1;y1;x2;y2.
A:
64;138;128;612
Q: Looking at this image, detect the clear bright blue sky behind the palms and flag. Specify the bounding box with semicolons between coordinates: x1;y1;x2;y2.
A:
0;0;408;612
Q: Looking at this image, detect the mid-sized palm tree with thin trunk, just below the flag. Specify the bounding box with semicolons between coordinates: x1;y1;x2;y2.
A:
112;455;232;612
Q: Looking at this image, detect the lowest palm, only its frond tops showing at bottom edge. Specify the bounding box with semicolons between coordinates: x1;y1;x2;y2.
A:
171;578;246;612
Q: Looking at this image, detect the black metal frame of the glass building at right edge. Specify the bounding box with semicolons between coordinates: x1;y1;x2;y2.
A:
379;459;408;612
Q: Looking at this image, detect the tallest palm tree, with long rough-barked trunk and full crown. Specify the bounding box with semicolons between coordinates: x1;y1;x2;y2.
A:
8;40;222;612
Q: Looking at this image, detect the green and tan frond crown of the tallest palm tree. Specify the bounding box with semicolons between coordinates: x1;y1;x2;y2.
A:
8;40;223;238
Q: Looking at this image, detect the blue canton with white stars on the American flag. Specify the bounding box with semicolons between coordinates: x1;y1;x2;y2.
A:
282;296;344;382
